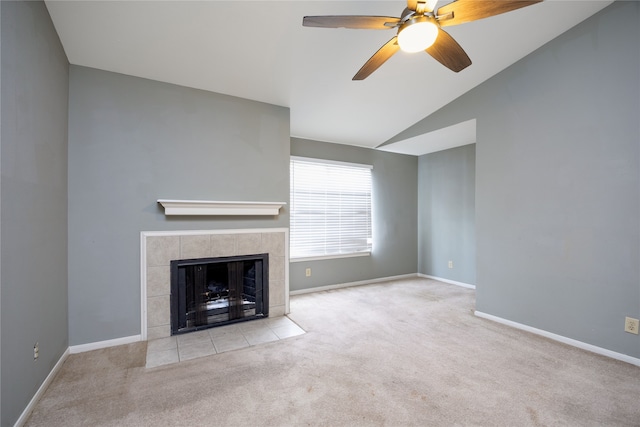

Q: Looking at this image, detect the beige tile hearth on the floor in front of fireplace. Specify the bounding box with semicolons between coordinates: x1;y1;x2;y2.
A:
146;316;305;368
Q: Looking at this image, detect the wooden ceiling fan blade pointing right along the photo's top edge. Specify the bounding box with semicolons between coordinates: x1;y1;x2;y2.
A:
436;0;542;27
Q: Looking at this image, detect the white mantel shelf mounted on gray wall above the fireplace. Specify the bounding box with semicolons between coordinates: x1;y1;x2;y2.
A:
158;199;286;216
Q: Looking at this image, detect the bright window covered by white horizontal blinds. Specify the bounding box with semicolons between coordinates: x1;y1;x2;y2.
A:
290;157;372;261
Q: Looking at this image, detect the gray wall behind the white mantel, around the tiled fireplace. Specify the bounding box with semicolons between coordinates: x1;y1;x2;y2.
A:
69;66;289;345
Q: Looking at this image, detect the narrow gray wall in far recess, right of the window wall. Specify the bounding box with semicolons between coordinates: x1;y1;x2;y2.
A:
418;144;476;285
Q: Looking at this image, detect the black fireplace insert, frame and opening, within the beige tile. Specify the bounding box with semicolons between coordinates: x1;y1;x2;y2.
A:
170;253;269;335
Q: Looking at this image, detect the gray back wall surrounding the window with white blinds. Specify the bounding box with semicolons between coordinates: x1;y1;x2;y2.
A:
289;138;418;290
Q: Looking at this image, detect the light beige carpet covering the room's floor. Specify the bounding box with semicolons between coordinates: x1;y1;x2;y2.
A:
22;279;640;427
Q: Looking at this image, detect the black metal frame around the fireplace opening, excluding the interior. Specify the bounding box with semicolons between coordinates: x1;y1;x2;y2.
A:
170;253;269;335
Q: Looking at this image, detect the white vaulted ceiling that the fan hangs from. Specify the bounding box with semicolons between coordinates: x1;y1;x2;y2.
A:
46;0;611;149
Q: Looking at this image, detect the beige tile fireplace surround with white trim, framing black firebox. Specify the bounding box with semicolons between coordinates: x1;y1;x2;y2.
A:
140;228;289;340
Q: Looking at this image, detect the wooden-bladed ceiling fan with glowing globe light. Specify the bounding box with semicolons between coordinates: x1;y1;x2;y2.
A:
302;0;542;80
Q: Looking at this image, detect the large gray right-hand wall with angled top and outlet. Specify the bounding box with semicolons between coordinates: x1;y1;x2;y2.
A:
384;2;640;358
